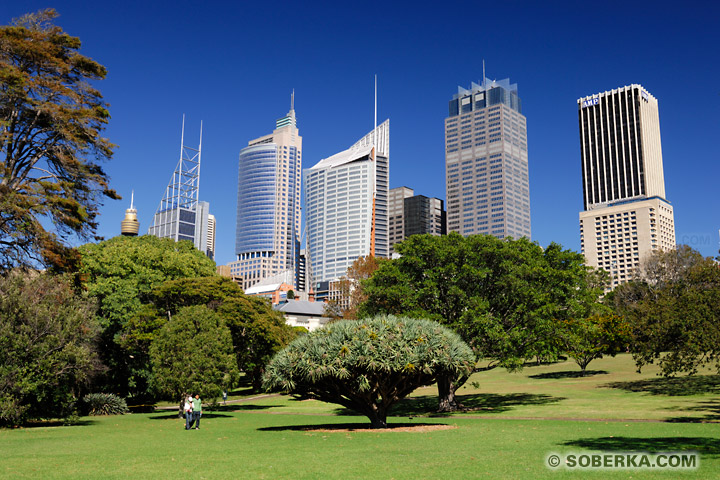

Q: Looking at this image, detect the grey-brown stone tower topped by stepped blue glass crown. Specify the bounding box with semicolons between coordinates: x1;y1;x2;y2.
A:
445;78;530;238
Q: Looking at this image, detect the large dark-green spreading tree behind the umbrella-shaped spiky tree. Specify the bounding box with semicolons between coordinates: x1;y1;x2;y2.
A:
359;233;605;411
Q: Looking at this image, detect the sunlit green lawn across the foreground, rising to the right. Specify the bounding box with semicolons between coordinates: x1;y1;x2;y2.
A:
0;355;720;479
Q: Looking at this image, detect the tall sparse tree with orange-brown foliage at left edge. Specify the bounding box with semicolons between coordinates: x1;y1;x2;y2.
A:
0;9;120;270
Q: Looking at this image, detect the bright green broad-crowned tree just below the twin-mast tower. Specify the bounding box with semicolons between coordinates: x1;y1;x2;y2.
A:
78;235;217;396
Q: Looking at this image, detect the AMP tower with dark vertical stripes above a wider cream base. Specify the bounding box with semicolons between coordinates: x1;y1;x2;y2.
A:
577;85;675;287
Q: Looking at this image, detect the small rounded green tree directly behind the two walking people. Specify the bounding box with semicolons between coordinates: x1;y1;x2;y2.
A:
150;306;238;400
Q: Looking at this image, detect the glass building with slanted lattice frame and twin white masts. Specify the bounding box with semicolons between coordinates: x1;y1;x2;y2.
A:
148;118;210;255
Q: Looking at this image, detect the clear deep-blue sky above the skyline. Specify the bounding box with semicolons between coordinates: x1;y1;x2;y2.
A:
5;0;720;264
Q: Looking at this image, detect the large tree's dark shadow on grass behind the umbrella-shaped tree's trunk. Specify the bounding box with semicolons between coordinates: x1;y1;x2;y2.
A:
335;393;565;417
